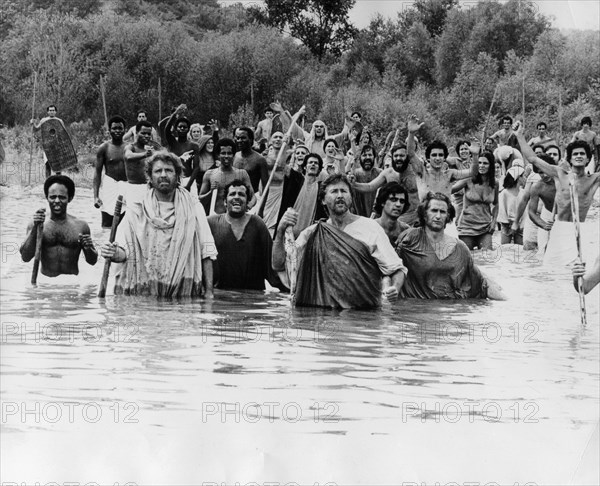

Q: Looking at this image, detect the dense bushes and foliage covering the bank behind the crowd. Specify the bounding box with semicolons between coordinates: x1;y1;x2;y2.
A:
0;0;600;147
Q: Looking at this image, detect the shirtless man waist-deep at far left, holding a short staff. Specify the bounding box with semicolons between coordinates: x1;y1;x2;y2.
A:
20;174;98;277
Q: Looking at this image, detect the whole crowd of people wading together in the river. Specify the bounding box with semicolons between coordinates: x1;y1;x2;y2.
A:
21;103;600;308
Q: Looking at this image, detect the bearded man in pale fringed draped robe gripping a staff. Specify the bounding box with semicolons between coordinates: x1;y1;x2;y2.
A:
101;151;217;298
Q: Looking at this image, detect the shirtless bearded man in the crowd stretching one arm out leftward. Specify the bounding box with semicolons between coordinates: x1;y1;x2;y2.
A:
352;140;421;225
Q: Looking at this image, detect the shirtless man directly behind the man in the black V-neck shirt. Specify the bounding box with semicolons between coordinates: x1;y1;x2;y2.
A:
199;138;256;214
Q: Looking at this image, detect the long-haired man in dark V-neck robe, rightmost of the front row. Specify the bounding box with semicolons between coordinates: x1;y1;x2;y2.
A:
397;192;503;300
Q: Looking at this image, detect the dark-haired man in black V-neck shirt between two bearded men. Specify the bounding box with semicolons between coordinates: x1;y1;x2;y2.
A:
208;179;273;290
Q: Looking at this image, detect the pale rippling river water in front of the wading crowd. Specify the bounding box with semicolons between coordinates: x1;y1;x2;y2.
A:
0;186;600;485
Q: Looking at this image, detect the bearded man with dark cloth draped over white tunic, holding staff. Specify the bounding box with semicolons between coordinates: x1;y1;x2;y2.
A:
273;174;406;308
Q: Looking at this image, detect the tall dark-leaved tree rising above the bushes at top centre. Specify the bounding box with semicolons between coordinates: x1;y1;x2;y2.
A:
250;0;358;61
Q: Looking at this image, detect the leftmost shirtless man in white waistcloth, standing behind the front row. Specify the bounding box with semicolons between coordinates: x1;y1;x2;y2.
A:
94;116;127;228
